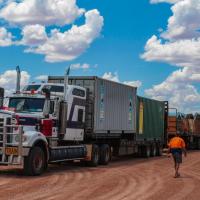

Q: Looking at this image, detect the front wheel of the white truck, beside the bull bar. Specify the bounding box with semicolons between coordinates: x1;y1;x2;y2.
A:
24;146;46;176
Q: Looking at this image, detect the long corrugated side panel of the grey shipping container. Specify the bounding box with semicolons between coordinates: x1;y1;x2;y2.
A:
94;78;136;133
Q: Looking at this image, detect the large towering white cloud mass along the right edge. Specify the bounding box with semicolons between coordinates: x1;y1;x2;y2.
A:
141;0;200;112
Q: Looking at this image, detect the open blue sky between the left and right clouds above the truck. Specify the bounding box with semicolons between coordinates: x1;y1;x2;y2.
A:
0;0;173;94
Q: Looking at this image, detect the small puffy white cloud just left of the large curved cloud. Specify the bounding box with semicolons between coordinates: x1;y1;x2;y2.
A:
20;24;48;46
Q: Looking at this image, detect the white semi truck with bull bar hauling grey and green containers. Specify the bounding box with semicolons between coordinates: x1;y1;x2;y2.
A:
0;72;166;175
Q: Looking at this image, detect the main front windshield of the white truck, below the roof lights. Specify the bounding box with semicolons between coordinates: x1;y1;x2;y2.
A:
8;97;45;112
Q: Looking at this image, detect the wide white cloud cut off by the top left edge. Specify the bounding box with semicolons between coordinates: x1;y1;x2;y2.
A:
0;0;84;25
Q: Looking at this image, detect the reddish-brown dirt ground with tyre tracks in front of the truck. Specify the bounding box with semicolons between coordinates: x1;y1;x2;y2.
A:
0;152;200;200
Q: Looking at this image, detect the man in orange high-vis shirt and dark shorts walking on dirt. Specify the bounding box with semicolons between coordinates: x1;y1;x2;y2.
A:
168;133;187;178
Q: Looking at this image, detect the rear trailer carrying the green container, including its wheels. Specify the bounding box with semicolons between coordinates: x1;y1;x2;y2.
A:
136;96;166;157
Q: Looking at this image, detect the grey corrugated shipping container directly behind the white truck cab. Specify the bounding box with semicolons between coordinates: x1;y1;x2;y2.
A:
48;76;137;137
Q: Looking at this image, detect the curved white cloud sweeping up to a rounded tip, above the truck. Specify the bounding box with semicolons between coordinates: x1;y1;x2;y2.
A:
26;9;103;62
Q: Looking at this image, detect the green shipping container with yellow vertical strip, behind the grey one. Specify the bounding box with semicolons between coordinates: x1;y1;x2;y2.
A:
136;96;165;142
